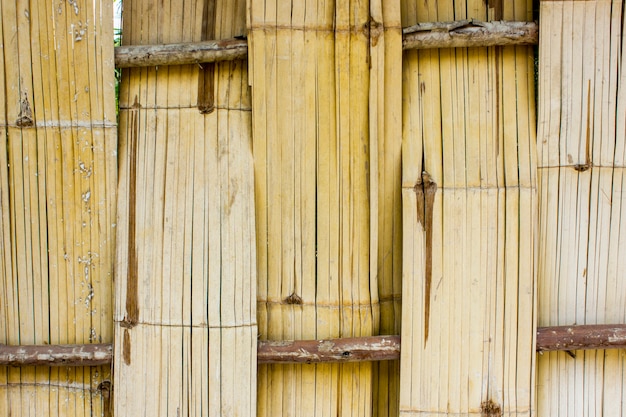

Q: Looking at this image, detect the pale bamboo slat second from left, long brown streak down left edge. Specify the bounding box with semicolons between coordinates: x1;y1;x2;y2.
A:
114;0;257;416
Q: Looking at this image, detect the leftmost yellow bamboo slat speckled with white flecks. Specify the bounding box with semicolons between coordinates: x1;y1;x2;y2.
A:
0;0;117;416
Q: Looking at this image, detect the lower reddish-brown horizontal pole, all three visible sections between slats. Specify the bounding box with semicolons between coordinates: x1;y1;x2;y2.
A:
0;324;626;366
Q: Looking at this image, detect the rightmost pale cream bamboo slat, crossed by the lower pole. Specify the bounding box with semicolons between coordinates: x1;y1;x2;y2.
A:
537;1;626;416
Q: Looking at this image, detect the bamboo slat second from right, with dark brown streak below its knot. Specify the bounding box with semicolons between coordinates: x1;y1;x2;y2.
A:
400;0;536;416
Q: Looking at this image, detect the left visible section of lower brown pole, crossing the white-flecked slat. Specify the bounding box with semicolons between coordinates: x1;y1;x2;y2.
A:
0;343;113;366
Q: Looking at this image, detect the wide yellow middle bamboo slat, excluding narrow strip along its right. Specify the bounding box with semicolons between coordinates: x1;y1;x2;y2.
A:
248;0;378;416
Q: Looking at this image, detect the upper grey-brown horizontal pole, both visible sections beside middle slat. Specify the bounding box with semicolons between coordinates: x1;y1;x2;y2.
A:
115;20;539;68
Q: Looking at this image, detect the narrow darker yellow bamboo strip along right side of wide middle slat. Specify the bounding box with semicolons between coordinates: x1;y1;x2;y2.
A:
369;0;402;417
